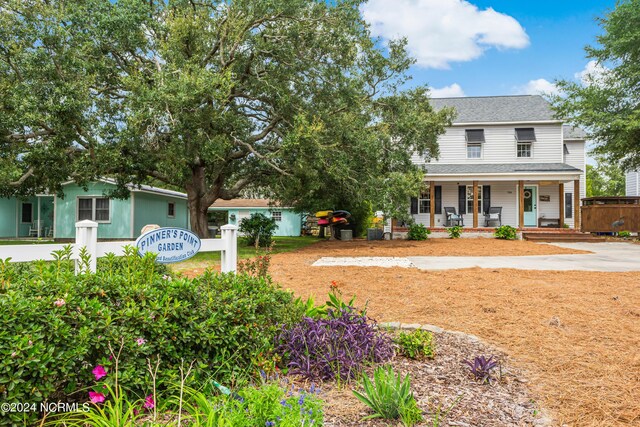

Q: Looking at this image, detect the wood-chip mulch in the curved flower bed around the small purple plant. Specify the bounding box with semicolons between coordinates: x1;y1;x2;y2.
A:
321;333;544;427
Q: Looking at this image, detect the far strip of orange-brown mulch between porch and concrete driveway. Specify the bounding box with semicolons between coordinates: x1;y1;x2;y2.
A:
284;237;590;257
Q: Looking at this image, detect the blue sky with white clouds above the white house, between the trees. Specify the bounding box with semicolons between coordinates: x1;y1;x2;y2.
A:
361;0;615;97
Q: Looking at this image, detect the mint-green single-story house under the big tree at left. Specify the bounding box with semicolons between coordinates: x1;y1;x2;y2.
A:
0;179;190;240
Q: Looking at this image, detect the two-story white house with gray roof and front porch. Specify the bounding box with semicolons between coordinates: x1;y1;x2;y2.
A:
411;95;586;229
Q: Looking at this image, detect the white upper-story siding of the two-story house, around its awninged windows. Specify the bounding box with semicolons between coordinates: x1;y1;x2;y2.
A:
412;124;563;164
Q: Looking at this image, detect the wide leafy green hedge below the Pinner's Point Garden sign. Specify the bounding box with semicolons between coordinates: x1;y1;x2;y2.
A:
0;255;302;425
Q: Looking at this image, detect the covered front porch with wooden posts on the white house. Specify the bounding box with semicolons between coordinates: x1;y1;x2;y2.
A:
395;164;583;231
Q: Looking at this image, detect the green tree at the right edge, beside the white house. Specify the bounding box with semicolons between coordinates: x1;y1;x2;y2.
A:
554;0;640;174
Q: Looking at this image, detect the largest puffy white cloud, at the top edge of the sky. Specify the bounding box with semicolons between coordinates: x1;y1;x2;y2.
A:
361;0;529;68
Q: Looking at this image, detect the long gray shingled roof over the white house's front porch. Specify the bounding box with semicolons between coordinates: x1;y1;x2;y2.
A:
424;163;582;175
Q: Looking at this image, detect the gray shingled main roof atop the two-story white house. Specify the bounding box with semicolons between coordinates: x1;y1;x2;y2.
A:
430;95;556;123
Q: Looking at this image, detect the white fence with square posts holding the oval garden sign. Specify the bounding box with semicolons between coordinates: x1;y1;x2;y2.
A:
0;220;238;273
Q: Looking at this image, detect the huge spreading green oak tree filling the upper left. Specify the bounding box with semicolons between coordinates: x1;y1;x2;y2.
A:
0;0;452;236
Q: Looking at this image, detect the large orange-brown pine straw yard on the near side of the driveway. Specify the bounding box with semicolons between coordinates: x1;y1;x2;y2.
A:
270;239;640;426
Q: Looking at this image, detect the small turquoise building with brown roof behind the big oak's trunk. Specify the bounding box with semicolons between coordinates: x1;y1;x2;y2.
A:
209;199;303;236
